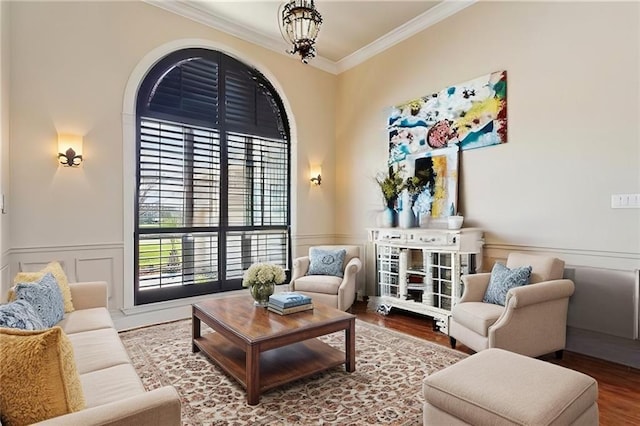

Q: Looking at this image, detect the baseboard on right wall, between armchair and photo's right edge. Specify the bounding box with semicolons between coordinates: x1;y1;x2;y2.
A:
566;327;640;369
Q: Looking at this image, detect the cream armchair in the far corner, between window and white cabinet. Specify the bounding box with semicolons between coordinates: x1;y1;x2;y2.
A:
290;246;362;311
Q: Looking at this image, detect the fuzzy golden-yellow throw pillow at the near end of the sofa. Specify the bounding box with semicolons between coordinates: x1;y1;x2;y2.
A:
0;327;85;425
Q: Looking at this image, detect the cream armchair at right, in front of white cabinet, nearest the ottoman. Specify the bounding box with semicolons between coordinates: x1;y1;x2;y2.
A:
449;253;575;358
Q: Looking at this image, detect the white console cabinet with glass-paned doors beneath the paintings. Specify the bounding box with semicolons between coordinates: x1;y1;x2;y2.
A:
368;228;484;334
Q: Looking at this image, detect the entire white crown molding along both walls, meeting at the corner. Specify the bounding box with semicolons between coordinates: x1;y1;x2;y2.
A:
143;0;477;74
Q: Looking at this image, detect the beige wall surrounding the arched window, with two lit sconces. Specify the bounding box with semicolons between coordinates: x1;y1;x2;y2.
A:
3;2;337;309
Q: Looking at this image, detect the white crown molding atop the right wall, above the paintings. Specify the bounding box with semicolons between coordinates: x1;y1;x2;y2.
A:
336;0;477;74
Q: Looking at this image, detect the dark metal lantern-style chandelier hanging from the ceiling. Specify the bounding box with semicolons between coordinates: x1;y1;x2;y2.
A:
280;0;322;64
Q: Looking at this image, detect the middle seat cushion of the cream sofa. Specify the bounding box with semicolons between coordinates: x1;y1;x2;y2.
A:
68;328;131;374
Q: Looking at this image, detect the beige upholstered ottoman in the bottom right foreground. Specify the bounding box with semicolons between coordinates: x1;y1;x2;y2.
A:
422;349;598;426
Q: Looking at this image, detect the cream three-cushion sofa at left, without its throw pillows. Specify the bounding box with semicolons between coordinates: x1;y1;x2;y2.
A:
38;282;180;426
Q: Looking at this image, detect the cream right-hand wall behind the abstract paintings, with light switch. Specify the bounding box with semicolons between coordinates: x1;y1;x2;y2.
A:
336;2;640;270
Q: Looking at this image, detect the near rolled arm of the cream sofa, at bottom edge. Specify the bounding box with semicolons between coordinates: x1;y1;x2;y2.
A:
37;386;181;426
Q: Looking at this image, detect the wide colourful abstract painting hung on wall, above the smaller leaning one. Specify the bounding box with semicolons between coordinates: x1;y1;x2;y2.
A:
387;71;507;164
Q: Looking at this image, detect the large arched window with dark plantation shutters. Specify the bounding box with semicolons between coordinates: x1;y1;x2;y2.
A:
134;48;291;305
